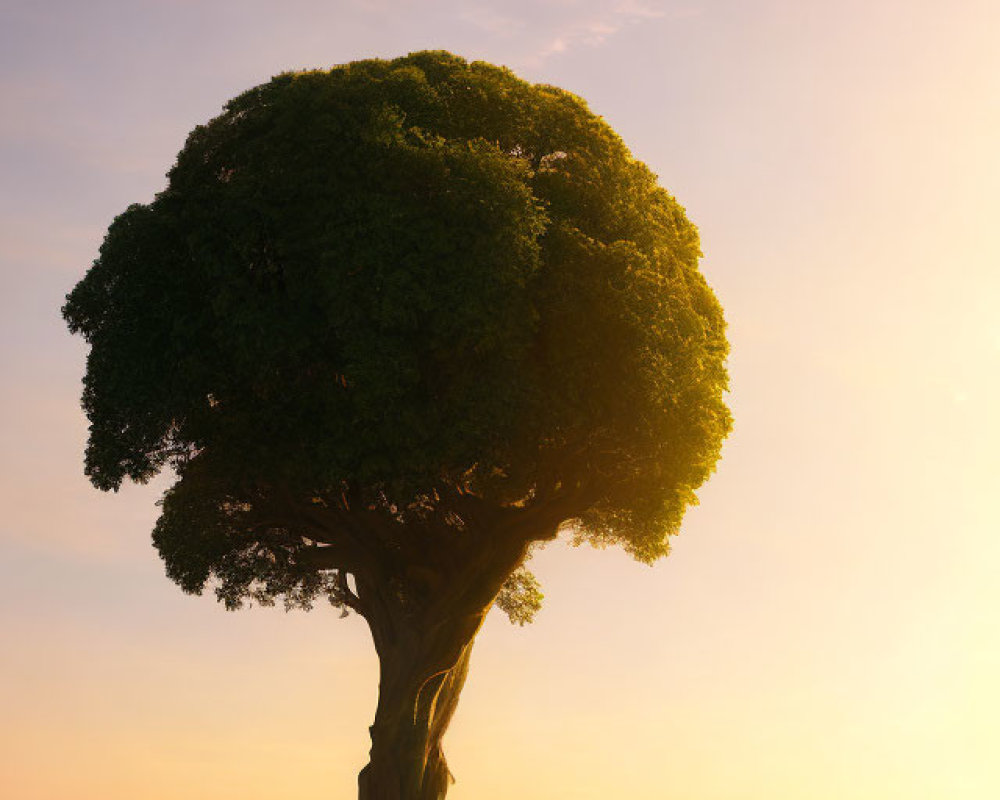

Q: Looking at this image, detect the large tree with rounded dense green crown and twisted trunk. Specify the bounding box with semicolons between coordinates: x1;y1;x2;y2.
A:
63;52;730;800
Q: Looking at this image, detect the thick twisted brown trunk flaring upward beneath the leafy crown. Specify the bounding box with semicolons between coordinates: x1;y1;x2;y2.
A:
346;510;554;800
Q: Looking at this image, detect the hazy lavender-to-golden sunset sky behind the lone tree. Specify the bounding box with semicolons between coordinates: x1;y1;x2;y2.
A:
0;0;1000;800
